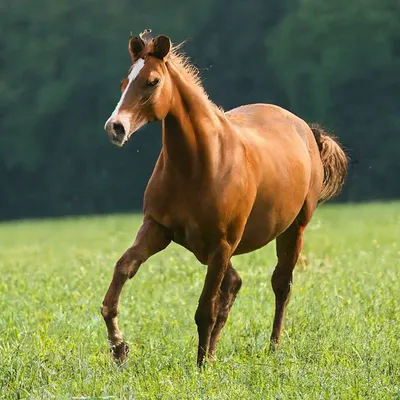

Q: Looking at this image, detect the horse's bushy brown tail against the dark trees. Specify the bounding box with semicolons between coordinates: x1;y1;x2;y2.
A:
310;124;348;203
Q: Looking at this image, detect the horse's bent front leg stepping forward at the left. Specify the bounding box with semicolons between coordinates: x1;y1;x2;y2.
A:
101;217;171;361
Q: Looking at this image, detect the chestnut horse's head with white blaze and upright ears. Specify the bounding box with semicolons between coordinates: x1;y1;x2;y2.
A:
104;30;172;147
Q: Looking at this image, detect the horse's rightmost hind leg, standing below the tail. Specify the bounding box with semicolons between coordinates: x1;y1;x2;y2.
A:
271;201;316;350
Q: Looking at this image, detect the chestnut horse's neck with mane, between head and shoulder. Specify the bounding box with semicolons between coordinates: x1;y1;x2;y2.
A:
163;66;221;178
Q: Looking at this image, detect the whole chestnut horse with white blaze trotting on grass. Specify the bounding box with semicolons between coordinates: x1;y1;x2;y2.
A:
101;30;347;366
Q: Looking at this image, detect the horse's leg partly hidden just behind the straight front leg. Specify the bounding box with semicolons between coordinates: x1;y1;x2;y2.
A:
208;263;242;361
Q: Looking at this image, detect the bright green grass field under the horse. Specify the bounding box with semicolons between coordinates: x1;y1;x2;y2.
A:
0;203;400;400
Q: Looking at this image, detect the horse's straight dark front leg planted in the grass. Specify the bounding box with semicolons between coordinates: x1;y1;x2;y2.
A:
195;241;233;367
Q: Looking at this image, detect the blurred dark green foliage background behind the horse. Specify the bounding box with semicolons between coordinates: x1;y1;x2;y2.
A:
0;0;400;218
